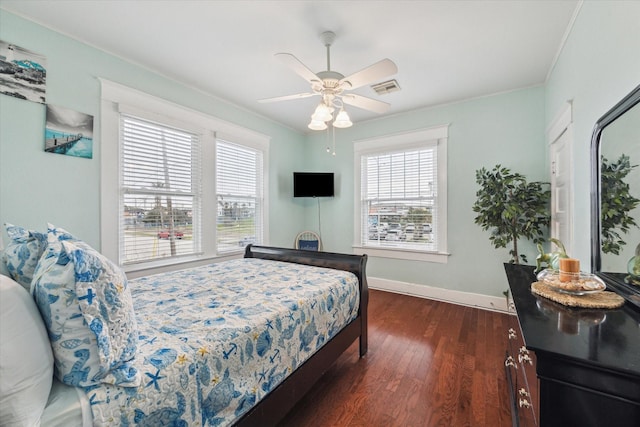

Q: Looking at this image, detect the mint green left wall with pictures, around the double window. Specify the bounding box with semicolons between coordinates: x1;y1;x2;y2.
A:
0;10;304;251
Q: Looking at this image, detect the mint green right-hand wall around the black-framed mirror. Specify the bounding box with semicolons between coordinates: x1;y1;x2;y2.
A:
545;1;640;266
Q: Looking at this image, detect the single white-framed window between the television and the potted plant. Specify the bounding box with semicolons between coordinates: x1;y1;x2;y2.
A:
354;127;447;262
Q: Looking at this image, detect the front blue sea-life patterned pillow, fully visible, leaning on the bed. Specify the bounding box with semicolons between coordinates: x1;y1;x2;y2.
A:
33;225;141;387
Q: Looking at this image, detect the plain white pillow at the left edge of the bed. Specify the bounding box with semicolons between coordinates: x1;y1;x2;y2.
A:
0;275;53;427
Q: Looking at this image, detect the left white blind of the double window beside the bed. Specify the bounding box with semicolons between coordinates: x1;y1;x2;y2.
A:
119;114;201;264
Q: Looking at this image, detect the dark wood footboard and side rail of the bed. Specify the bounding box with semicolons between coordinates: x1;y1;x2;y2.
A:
235;245;369;427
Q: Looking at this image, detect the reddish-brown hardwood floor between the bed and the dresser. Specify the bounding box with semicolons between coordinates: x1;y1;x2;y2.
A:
281;290;511;427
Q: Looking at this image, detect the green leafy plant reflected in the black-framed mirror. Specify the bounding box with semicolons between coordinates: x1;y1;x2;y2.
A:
600;154;640;255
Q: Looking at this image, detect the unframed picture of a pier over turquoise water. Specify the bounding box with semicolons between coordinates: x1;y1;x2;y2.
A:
44;104;93;159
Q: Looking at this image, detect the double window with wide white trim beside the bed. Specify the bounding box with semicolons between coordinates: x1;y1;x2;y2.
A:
100;79;269;277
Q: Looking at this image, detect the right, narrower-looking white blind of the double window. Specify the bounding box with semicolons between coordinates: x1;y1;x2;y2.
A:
216;139;264;253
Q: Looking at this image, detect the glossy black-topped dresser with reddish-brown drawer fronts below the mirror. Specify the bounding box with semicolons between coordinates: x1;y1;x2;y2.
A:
505;264;640;427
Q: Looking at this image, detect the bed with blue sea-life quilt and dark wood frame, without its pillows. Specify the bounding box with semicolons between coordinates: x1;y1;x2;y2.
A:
0;224;368;426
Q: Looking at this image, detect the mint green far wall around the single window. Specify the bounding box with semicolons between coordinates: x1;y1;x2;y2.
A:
307;87;545;296
